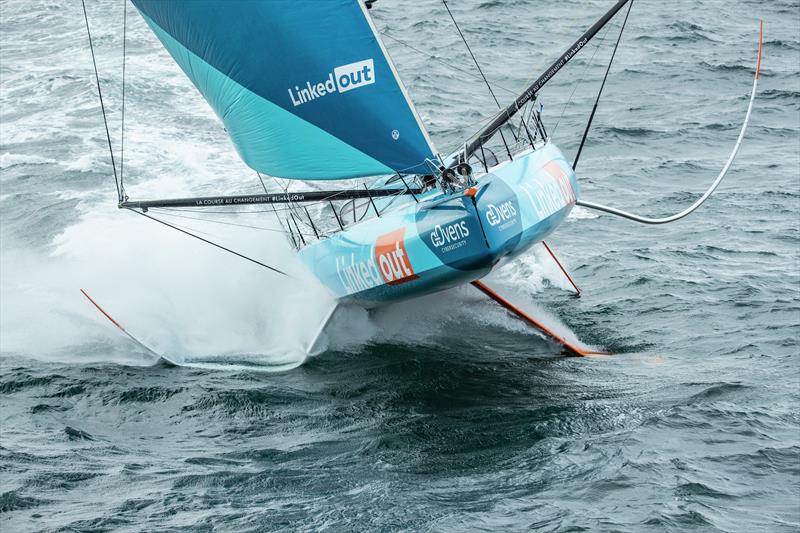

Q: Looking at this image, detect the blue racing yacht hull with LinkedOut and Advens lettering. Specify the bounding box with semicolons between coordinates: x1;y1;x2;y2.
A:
299;143;578;307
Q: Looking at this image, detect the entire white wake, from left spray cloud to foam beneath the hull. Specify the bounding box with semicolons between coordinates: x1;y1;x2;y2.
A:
0;191;592;372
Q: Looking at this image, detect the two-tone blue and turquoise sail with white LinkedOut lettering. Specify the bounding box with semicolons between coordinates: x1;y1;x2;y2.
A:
132;0;435;179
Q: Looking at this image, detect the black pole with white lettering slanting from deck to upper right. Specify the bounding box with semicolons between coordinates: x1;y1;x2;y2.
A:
464;0;629;160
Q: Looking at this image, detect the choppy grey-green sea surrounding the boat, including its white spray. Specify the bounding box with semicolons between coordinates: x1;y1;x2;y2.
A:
0;0;800;532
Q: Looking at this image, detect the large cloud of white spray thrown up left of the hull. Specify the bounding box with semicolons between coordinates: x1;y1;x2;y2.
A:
0;195;331;370
